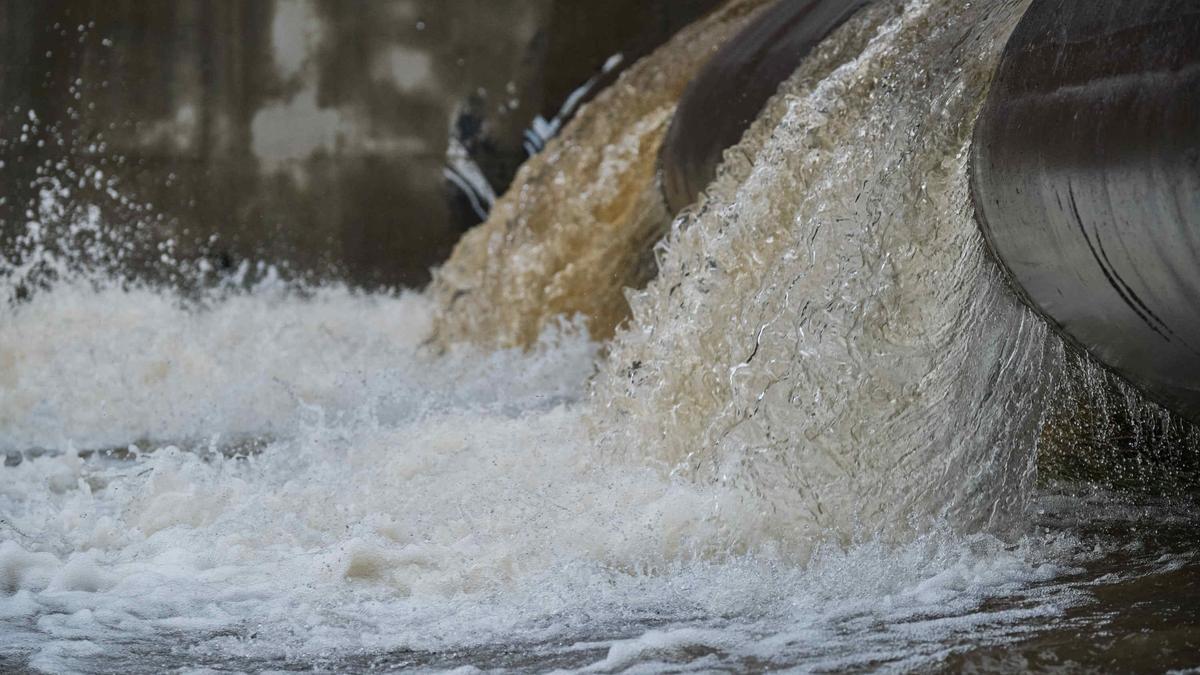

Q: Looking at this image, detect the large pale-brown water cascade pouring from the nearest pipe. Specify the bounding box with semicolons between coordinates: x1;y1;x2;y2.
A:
596;2;1061;545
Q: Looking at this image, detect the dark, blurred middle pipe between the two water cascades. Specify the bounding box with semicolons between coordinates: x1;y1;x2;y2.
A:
659;0;871;213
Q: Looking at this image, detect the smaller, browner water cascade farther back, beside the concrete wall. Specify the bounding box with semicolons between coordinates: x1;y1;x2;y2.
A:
431;0;767;347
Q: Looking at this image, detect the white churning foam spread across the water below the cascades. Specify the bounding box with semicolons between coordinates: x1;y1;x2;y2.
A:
0;273;1099;671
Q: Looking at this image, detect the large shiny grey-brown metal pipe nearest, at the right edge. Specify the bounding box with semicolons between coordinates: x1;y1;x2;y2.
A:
971;0;1200;422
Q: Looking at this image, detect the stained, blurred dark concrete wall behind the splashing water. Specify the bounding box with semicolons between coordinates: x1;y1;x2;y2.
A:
0;0;716;286
